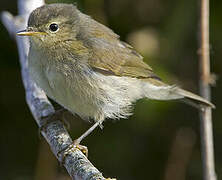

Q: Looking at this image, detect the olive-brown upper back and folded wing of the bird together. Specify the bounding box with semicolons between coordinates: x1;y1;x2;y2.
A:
74;16;159;79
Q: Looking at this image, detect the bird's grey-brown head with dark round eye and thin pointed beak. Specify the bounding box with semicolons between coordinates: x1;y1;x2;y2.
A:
17;4;79;46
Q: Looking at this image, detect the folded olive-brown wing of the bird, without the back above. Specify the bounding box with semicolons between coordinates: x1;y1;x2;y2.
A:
85;32;158;78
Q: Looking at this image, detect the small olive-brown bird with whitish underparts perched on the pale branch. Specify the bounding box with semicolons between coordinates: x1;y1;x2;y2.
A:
17;3;215;147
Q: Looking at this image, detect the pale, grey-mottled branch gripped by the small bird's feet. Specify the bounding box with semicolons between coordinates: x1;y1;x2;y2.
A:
1;0;110;180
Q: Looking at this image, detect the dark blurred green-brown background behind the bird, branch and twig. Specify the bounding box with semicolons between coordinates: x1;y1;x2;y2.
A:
0;0;222;180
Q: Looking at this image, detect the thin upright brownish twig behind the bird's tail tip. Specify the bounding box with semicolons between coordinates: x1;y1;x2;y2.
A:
200;0;217;180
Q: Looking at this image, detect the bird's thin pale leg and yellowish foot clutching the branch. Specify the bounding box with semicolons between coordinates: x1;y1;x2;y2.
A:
58;120;103;164
